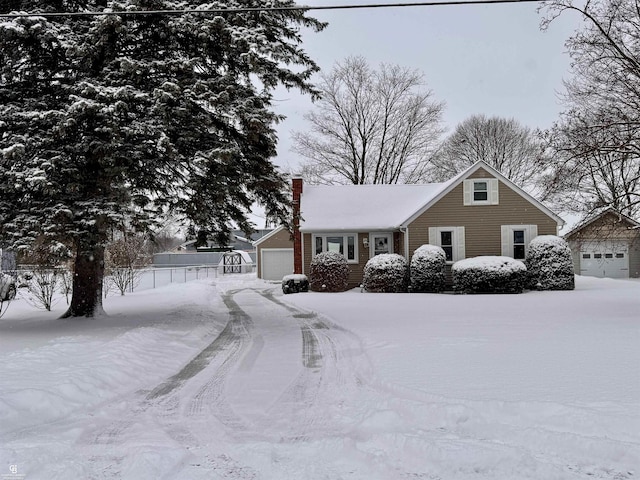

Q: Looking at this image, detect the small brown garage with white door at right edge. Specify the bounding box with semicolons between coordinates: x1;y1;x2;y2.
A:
564;208;640;278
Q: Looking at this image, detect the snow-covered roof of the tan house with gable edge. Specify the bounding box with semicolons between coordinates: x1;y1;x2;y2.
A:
300;162;564;232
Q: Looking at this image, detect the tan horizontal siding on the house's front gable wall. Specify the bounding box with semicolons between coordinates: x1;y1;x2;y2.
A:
409;174;557;258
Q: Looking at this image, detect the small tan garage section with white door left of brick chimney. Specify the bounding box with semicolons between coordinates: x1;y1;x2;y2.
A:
254;227;293;281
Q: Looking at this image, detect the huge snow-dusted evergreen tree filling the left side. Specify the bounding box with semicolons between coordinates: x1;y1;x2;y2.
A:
0;0;324;317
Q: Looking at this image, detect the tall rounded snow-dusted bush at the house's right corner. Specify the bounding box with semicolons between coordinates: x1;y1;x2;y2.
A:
525;235;575;290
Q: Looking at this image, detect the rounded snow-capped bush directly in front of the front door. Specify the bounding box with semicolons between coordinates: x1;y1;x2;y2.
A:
363;253;409;293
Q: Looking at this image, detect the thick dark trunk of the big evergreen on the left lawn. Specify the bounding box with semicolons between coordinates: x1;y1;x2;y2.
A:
61;241;104;318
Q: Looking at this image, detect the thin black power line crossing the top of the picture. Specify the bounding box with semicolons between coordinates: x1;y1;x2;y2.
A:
0;0;548;18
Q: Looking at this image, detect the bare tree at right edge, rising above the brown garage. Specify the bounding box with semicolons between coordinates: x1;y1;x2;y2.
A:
541;0;640;215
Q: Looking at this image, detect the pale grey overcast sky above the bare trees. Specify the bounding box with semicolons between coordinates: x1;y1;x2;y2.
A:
276;0;582;171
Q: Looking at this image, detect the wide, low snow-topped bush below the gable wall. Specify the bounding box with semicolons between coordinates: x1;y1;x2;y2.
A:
451;256;527;293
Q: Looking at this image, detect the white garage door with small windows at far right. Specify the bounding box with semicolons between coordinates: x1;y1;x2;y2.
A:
580;242;629;278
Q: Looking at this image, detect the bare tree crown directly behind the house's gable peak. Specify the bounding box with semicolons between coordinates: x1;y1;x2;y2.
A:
431;115;546;193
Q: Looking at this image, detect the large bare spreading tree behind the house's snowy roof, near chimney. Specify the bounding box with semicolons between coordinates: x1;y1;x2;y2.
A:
293;57;444;185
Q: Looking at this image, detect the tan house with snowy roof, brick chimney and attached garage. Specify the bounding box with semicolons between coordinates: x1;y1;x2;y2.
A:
256;162;564;286
